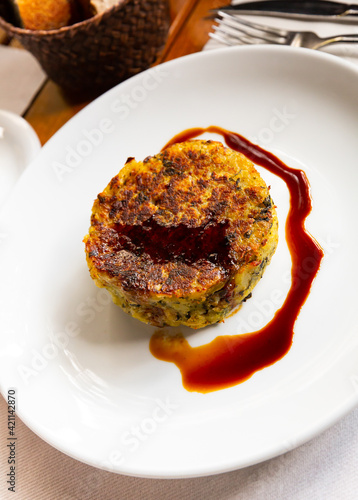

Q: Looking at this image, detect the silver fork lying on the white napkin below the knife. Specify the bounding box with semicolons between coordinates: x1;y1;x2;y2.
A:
209;11;358;49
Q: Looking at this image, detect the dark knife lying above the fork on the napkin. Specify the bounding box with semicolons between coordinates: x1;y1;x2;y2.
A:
215;0;358;21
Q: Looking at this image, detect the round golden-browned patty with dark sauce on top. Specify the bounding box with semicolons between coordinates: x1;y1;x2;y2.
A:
84;140;278;328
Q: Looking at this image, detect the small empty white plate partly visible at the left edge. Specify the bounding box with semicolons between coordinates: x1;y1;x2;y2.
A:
0;110;41;205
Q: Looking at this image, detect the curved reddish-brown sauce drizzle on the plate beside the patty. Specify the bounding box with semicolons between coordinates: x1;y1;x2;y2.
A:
150;126;323;393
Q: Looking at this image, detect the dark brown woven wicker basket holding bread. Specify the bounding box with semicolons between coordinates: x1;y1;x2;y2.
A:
0;0;169;91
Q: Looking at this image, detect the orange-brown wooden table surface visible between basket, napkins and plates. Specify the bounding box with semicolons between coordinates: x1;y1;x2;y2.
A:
0;0;224;145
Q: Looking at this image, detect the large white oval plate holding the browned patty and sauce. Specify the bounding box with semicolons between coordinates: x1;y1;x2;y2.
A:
0;46;358;478
